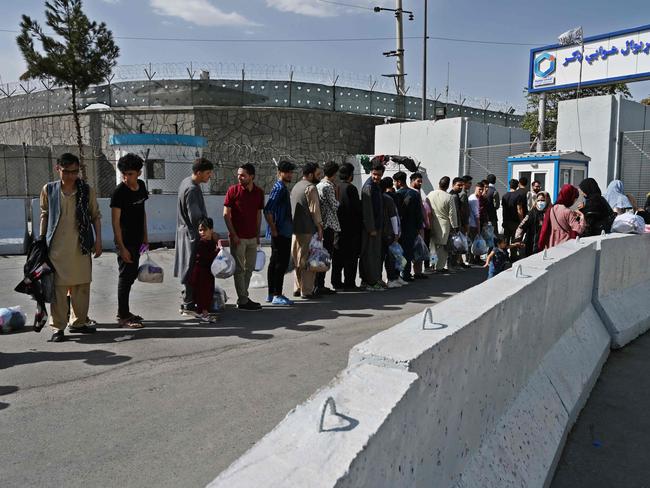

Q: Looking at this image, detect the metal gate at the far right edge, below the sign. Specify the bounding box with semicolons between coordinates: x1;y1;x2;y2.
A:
620;130;650;207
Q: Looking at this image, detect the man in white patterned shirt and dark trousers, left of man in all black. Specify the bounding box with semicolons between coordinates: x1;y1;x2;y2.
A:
316;161;341;295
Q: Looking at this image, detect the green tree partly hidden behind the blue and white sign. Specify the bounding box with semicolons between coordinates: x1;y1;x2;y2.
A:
521;83;632;144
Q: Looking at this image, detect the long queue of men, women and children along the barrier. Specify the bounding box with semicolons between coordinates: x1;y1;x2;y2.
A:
33;153;650;342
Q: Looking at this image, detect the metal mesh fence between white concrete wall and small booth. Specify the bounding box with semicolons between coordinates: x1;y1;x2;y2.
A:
460;140;555;194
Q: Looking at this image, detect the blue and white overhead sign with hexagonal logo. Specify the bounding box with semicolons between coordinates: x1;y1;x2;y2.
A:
528;25;650;93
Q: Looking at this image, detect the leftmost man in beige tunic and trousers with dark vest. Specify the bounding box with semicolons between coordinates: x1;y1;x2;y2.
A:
40;153;102;342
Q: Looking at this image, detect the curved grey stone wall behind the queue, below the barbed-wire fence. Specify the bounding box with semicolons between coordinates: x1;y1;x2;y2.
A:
0;107;383;196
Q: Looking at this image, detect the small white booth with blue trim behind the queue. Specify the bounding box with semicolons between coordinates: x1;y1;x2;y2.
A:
508;151;591;202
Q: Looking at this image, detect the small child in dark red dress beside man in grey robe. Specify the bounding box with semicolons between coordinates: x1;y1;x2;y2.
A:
189;217;219;322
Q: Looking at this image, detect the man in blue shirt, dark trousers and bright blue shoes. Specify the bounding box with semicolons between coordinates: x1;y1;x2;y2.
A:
264;161;296;305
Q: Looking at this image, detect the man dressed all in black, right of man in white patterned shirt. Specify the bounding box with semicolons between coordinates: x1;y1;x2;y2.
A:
332;163;362;291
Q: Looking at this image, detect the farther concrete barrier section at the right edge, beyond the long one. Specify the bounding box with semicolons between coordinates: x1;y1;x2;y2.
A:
593;234;650;348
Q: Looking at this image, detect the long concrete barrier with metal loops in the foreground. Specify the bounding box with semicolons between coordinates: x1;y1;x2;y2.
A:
210;241;609;488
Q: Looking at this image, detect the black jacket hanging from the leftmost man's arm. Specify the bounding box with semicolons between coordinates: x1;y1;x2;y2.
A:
14;239;54;332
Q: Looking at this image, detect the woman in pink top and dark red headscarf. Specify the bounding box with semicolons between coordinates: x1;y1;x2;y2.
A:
537;184;586;251
